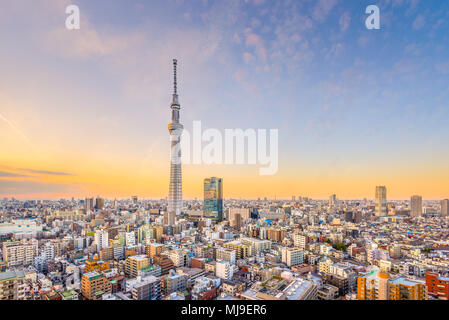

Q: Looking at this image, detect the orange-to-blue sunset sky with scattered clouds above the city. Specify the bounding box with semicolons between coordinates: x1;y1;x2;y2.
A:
0;0;449;199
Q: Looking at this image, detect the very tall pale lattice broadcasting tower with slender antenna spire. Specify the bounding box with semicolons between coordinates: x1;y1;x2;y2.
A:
168;59;184;221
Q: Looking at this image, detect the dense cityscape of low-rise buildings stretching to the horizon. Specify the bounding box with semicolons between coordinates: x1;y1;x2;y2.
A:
0;191;449;300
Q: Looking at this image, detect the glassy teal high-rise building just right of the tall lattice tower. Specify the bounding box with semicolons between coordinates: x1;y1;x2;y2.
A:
204;177;223;222
